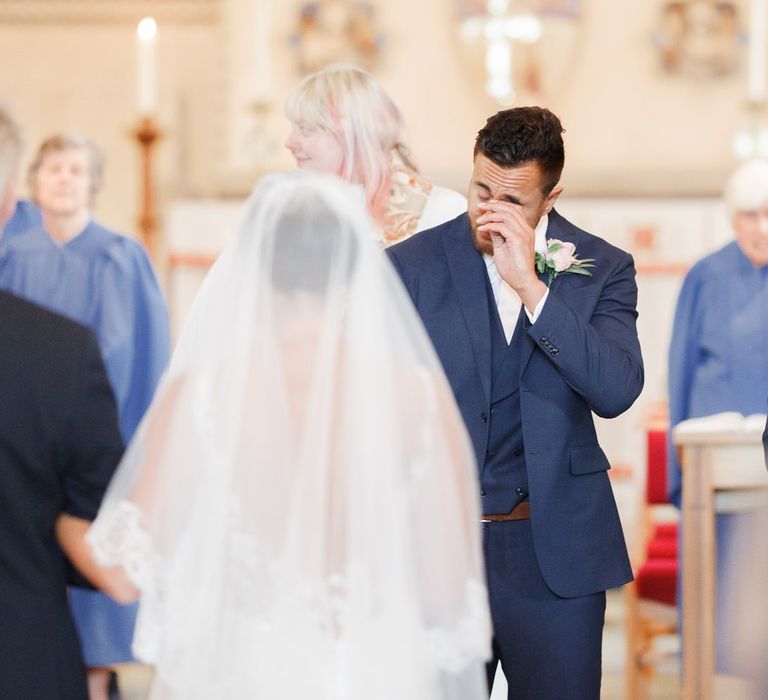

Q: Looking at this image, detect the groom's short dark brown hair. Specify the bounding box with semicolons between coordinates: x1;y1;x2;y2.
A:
474;107;565;195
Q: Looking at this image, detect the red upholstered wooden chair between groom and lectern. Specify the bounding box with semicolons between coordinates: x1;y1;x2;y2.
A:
626;424;678;700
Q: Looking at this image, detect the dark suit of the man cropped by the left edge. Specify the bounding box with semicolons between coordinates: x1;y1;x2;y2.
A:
0;291;123;700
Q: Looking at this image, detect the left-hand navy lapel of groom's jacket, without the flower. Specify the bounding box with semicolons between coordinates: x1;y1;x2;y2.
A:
442;215;491;400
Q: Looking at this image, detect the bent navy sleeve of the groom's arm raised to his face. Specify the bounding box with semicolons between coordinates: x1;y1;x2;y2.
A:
528;255;644;418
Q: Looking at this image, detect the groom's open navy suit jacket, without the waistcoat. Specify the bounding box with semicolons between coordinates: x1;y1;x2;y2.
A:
387;211;643;597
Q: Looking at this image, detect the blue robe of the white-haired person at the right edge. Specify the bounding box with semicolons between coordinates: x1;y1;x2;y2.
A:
668;241;768;672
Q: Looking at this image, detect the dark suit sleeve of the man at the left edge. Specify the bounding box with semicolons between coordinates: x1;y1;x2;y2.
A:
62;333;123;520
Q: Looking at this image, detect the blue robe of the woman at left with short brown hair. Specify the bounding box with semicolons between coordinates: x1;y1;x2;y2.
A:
0;203;170;667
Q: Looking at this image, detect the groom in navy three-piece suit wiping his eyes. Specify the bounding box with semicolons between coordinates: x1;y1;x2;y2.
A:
388;107;643;700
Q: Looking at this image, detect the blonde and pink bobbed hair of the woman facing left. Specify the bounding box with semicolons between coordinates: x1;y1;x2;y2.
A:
285;64;416;220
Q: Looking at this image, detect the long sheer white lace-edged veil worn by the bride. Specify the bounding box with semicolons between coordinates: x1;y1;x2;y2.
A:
89;172;490;700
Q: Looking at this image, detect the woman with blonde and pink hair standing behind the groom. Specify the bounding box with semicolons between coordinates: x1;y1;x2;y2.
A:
285;65;467;246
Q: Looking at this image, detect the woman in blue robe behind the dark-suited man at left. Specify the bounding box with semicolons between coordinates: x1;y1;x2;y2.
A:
0;134;170;699
